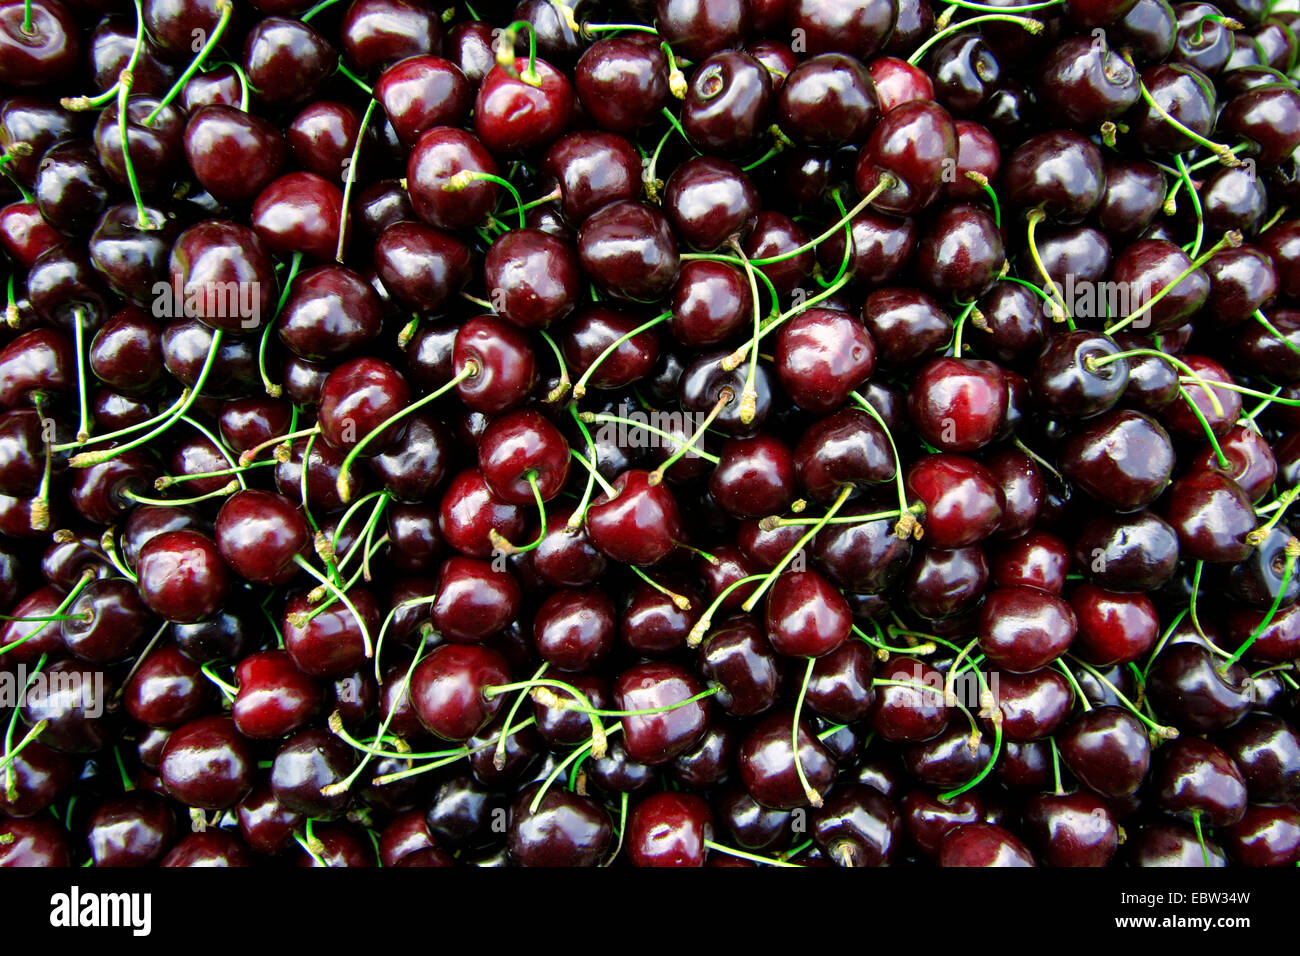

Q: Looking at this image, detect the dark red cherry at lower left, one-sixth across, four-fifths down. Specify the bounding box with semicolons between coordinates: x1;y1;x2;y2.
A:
159;717;256;810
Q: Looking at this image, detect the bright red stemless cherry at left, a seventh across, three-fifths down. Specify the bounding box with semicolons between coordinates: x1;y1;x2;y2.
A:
137;531;230;624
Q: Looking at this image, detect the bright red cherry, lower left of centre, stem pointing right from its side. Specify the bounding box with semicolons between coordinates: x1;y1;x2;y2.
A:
411;644;510;740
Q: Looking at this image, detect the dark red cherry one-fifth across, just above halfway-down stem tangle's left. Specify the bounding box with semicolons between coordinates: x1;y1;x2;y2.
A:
216;488;311;585
